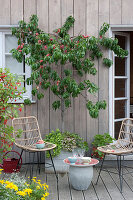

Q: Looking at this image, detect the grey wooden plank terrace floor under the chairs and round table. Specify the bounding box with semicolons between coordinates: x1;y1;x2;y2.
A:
2;163;133;200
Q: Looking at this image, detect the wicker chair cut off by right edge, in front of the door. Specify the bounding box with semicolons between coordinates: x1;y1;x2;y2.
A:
96;118;133;193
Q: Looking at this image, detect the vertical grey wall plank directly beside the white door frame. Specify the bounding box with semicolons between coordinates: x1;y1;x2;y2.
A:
98;0;109;134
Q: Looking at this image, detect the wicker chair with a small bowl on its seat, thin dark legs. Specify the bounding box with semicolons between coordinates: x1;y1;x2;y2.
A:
12;116;58;179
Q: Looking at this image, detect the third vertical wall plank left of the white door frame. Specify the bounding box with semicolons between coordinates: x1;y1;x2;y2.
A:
74;0;87;142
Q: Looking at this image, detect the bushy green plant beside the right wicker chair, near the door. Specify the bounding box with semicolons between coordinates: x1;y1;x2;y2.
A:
91;133;115;159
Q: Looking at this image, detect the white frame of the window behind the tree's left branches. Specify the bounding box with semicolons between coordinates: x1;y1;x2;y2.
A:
0;25;34;103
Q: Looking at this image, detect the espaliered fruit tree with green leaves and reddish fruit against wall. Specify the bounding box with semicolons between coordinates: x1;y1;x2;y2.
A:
11;15;128;129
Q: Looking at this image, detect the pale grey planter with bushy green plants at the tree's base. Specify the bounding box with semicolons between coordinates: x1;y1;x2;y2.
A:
44;129;89;172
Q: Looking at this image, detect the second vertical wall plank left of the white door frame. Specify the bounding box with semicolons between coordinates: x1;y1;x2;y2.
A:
86;0;99;143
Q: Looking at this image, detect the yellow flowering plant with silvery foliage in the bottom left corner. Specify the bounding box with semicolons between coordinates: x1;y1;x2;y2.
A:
0;171;49;200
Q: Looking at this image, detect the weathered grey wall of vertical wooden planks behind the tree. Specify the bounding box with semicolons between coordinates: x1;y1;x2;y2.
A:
0;0;133;148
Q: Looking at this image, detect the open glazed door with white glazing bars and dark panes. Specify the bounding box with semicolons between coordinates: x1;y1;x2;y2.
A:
109;31;130;138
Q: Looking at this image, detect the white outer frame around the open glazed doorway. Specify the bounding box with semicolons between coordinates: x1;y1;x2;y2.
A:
109;25;133;137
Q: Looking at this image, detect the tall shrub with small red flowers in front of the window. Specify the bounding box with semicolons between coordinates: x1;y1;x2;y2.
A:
0;68;24;159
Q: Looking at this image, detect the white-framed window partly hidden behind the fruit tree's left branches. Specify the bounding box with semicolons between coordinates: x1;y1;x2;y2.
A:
0;28;32;103
